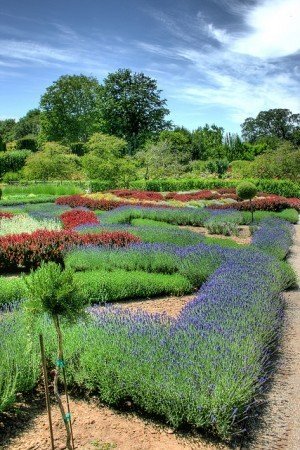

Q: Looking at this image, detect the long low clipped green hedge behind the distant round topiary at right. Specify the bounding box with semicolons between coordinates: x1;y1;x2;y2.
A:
131;178;300;197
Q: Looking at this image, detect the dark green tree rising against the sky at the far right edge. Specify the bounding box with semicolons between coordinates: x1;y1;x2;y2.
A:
241;108;300;142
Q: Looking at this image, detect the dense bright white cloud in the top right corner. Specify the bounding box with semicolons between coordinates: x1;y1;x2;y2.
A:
231;0;300;58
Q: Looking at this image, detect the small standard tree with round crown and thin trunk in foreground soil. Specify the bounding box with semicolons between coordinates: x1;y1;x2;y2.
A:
24;262;86;450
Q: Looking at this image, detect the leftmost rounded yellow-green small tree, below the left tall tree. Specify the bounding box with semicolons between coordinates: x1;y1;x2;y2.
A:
24;142;79;180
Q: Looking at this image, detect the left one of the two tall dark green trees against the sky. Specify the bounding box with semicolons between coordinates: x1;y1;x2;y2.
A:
40;75;101;143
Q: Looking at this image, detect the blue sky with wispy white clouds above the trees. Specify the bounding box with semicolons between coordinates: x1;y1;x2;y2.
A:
0;0;300;131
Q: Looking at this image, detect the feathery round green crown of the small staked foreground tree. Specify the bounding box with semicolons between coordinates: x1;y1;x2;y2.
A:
24;262;88;321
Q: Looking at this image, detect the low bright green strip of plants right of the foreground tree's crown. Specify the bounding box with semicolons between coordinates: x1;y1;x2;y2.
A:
74;270;193;304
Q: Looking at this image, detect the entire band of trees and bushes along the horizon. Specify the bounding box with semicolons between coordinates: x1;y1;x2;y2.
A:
0;69;300;186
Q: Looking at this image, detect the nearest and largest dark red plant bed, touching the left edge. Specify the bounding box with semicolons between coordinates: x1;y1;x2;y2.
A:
0;230;140;271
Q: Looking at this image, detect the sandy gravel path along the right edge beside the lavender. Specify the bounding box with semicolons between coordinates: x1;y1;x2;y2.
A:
243;225;300;450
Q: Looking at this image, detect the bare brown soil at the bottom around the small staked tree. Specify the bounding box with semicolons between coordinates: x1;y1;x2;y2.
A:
0;401;226;450
